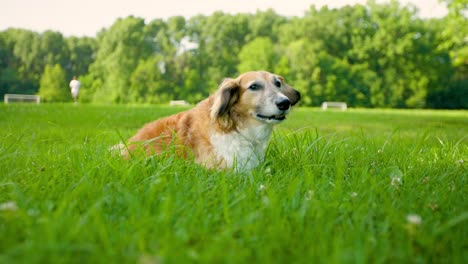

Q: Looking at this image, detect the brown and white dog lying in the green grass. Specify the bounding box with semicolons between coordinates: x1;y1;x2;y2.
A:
121;71;301;171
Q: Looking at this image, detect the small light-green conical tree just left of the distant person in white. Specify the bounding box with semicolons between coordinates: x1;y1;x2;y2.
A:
39;64;71;102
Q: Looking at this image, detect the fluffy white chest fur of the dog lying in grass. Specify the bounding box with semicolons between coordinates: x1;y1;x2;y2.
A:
210;124;273;170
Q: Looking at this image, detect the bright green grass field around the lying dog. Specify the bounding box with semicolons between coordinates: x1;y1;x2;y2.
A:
0;104;468;263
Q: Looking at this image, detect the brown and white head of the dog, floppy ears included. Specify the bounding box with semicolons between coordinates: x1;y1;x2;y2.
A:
211;71;301;129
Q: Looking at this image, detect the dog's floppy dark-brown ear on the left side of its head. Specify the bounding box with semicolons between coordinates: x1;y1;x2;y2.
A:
210;78;239;119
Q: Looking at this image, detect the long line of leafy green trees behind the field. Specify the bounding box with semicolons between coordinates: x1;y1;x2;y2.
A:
0;0;468;108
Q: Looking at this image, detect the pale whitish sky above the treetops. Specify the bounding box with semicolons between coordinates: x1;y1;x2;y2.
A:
0;0;447;37
